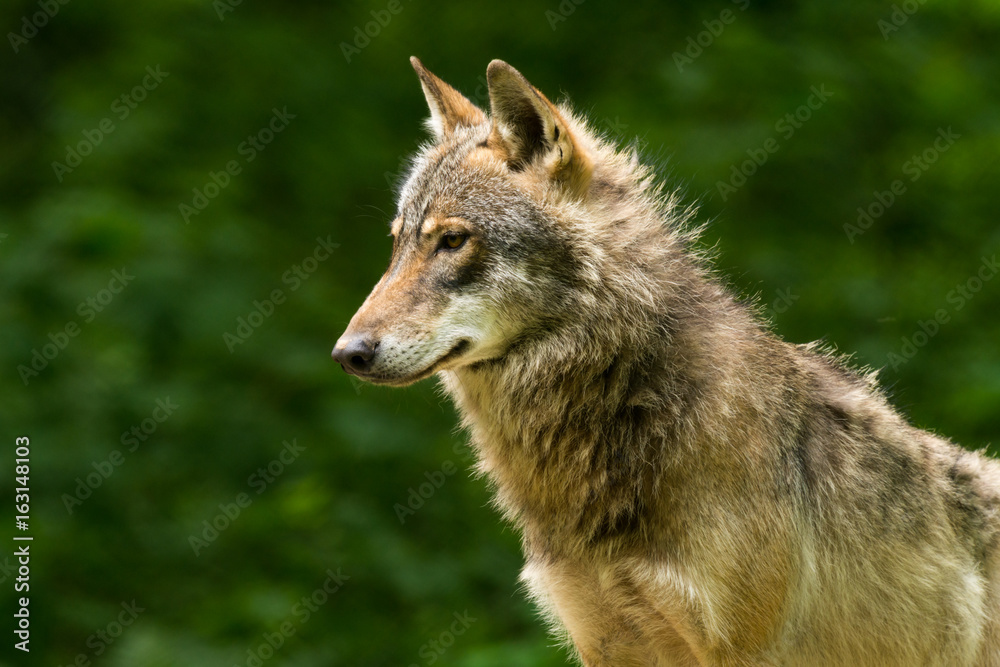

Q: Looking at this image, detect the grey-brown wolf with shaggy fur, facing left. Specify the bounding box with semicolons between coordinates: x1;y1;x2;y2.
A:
333;59;1000;667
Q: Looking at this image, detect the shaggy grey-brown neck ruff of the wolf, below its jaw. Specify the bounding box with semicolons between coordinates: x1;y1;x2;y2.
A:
442;248;767;551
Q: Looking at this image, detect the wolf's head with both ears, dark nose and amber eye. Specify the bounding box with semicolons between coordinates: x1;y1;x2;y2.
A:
333;58;680;386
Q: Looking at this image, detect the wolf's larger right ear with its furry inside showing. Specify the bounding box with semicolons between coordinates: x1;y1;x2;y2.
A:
486;60;593;195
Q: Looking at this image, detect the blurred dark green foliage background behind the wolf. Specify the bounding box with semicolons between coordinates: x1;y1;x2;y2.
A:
0;0;1000;667
